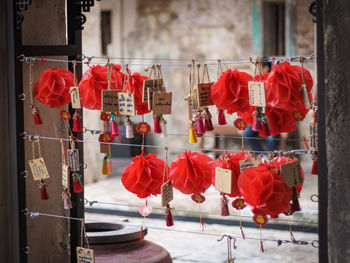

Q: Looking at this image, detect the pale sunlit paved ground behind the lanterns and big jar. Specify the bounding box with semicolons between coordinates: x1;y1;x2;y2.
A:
85;156;318;263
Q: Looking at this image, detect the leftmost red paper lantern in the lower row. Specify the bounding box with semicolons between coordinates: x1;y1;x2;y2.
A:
122;152;164;198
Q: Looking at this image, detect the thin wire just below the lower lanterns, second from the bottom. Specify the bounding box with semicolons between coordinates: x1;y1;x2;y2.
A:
84;198;318;225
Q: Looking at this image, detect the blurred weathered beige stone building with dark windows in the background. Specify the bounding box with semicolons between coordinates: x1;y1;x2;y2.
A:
83;0;316;184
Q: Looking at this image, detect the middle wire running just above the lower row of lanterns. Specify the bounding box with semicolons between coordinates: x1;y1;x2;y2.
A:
21;132;309;154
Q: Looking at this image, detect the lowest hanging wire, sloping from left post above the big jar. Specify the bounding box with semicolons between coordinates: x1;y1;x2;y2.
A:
24;209;315;249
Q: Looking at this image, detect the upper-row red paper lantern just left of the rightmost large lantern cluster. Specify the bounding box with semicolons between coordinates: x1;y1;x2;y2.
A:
210;69;253;114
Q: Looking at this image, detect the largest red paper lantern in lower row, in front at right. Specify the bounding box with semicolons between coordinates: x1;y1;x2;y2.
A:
238;164;292;216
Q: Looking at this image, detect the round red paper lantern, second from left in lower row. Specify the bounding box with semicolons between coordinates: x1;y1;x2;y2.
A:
169;151;213;195
